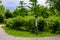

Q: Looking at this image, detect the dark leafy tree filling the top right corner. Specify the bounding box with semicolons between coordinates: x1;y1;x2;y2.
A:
47;0;60;15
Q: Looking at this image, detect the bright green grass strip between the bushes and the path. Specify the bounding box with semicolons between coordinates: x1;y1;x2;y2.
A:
2;26;60;37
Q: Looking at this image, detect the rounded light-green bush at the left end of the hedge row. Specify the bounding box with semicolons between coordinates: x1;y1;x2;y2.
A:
6;16;24;30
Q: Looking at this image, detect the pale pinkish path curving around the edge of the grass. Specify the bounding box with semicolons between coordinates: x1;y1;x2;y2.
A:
0;25;60;40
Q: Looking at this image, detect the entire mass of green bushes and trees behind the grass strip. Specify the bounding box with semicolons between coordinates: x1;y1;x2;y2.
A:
0;0;60;33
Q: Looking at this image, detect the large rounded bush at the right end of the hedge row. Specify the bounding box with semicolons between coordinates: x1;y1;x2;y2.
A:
48;17;60;33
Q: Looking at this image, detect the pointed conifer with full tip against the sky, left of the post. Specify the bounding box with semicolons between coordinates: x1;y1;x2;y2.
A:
13;1;28;16
